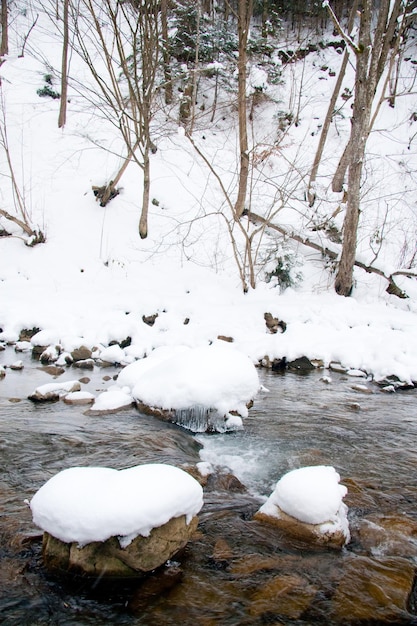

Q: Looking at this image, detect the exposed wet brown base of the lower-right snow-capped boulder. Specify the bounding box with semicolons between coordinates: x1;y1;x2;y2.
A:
254;506;346;548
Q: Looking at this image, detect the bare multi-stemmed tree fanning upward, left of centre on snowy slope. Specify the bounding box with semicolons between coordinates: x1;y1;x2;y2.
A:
73;0;160;239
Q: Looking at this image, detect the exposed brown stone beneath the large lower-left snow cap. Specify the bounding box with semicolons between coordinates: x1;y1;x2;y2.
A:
42;515;198;578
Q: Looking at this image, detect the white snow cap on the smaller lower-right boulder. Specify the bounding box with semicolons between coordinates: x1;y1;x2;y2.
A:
260;465;348;535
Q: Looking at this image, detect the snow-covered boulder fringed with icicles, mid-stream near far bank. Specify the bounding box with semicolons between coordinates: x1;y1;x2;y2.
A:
118;341;260;432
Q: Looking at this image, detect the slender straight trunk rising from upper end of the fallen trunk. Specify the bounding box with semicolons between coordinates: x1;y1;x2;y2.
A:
234;0;253;217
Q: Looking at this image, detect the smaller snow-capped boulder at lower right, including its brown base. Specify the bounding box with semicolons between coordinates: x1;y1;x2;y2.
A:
255;465;350;547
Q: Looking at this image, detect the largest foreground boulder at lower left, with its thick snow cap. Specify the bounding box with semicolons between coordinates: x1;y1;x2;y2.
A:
29;464;203;577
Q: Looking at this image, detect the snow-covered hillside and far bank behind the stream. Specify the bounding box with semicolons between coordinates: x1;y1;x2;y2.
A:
0;3;417;382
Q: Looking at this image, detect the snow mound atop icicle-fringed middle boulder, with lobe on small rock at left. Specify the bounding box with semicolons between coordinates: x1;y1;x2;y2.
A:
87;341;260;422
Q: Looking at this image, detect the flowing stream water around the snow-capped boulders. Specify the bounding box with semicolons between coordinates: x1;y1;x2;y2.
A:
0;348;417;626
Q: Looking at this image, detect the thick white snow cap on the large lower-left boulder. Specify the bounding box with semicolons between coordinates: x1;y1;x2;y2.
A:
30;463;203;548
